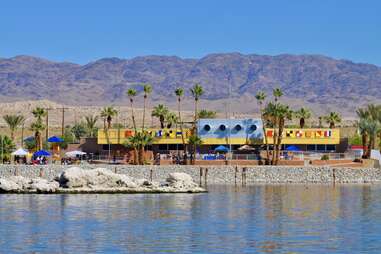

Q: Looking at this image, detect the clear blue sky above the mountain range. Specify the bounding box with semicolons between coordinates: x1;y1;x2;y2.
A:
0;0;381;66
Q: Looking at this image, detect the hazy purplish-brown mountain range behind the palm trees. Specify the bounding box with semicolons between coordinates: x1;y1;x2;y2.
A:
0;53;381;115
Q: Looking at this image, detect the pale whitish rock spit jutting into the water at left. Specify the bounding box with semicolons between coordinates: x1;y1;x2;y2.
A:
0;167;206;193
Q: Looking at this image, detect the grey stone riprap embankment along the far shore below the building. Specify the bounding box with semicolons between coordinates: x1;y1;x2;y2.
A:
0;165;381;185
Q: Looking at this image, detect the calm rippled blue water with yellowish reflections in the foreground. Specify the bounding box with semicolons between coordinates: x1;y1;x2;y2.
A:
0;185;381;253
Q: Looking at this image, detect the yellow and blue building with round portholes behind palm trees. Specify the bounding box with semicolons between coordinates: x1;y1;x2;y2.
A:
97;119;341;154
